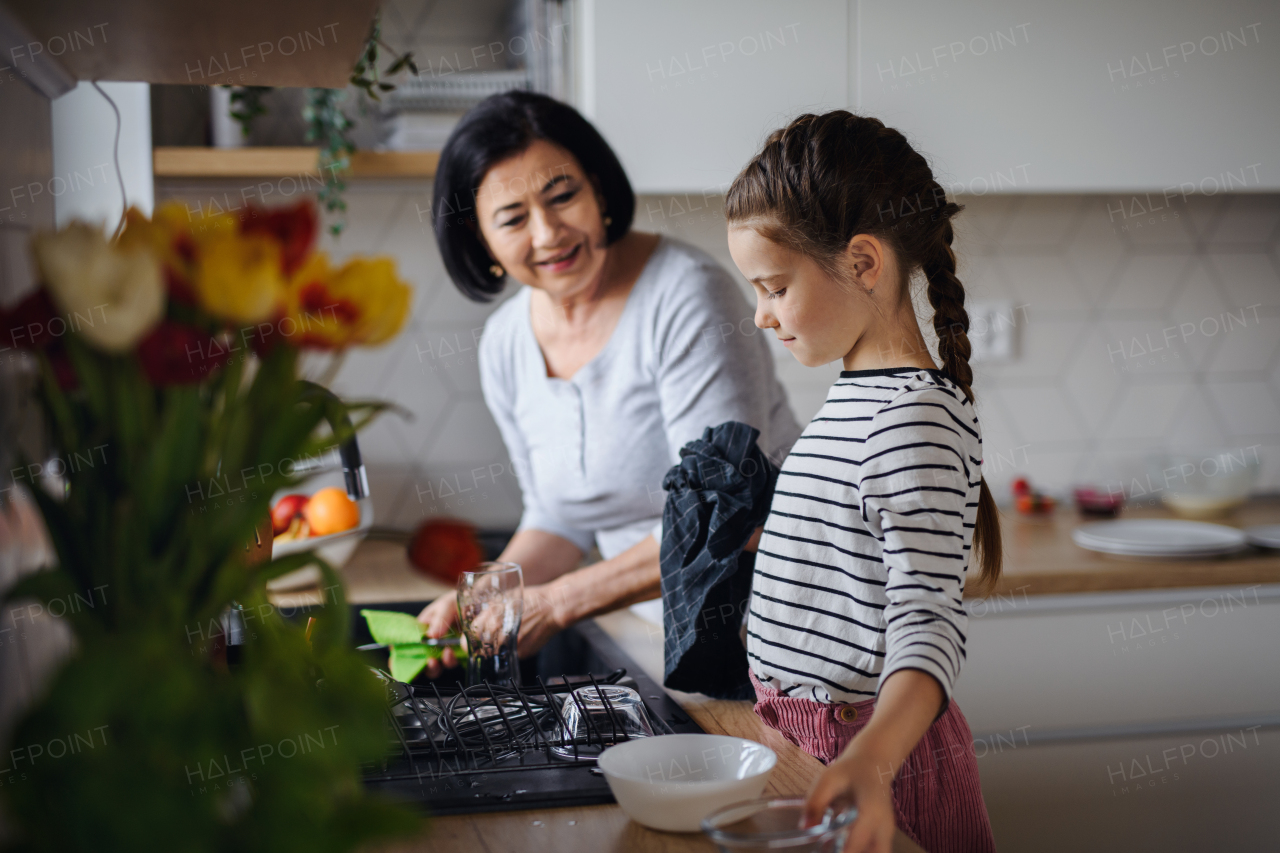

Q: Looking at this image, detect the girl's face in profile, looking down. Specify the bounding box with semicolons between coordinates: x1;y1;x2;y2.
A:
728;227;884;368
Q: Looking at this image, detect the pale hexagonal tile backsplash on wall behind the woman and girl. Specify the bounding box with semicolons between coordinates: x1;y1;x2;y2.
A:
157;181;1280;528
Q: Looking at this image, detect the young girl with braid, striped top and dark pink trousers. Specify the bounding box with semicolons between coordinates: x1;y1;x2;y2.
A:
726;110;1001;853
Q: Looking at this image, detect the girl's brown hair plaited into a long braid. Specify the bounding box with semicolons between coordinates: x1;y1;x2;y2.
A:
724;110;1002;589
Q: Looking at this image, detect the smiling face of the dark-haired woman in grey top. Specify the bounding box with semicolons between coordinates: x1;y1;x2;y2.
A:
476;140;608;297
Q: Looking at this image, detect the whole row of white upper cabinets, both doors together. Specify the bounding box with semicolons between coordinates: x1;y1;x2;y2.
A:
576;0;1280;192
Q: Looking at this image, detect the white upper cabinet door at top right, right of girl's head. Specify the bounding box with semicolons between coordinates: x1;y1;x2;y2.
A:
854;0;1280;195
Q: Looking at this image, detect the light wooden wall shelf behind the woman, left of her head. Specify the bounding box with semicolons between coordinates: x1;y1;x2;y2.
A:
152;147;440;178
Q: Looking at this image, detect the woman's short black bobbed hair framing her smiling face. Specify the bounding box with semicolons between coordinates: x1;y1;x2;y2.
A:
431;91;636;302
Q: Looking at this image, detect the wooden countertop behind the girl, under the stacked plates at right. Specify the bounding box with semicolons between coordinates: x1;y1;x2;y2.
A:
968;497;1280;597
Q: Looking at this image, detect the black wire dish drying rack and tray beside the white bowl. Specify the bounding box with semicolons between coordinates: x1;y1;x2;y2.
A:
352;614;701;815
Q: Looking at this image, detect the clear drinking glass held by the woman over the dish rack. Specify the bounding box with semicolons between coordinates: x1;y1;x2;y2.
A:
458;562;525;686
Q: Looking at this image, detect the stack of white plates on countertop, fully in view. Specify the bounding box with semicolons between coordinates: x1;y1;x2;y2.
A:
1071;519;1247;558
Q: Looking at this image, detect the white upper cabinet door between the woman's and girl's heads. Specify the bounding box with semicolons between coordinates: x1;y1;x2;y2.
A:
575;0;850;193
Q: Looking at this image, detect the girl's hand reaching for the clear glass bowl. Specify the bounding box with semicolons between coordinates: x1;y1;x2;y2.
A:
804;751;897;853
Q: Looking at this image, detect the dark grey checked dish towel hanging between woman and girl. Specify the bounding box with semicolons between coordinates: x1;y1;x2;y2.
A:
660;420;778;699
